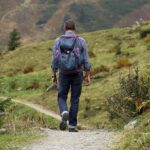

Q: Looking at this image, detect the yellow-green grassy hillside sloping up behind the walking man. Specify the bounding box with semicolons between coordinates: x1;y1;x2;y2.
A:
0;25;150;149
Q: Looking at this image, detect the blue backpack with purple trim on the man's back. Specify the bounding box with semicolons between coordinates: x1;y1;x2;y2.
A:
56;36;83;72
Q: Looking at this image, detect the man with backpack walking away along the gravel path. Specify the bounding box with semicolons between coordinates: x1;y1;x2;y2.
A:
52;20;91;132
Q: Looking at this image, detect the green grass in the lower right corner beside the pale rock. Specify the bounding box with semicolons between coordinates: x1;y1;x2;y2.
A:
116;113;150;150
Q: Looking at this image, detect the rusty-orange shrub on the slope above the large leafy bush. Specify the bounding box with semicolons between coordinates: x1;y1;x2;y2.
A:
116;56;131;69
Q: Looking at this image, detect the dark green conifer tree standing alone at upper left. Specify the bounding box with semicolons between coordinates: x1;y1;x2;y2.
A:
8;29;21;50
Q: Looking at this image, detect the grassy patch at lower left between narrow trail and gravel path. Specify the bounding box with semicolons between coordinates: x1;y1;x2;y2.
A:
0;99;58;150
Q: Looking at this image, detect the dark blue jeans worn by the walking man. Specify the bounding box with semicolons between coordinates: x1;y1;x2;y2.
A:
58;73;83;126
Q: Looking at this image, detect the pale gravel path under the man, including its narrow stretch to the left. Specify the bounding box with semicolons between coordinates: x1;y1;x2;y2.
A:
0;97;119;150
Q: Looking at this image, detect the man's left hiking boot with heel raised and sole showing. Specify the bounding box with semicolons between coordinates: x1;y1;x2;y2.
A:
59;111;69;130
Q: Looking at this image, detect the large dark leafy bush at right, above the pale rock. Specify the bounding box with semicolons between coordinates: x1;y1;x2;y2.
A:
107;69;150;121
